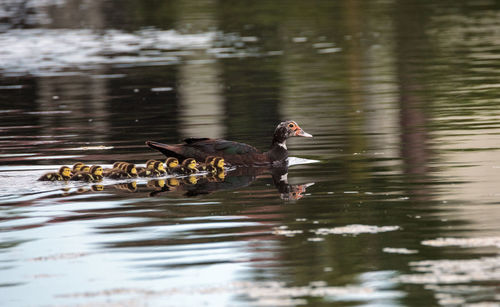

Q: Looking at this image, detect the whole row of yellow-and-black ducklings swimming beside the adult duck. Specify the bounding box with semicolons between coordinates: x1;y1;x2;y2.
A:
38;156;225;182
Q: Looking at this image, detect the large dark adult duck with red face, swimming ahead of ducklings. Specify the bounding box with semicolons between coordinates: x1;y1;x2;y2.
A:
146;120;312;166
